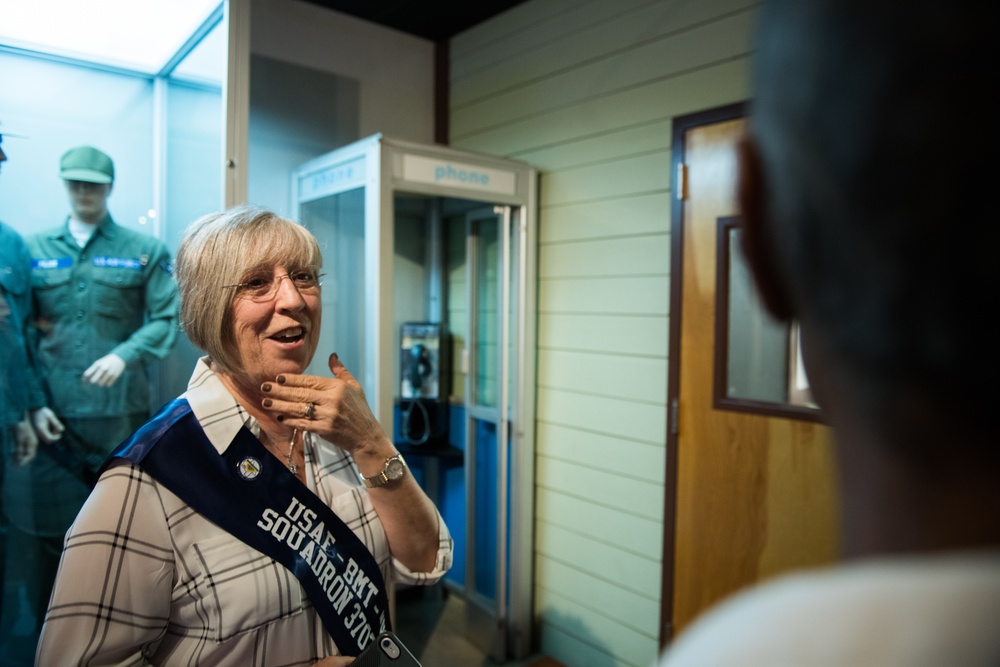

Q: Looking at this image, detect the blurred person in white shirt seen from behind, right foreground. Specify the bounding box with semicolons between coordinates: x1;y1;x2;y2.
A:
663;0;1000;667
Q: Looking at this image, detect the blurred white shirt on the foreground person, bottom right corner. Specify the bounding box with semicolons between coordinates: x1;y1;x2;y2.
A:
660;551;1000;667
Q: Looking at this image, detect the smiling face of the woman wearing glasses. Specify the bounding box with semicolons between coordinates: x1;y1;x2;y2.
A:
233;265;323;385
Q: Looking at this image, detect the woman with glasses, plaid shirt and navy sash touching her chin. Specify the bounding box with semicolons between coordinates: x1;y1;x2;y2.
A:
37;207;452;667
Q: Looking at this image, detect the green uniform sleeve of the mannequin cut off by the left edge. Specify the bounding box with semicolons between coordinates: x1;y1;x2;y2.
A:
0;222;45;429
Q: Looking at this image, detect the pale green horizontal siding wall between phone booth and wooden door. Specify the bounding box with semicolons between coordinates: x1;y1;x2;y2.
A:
450;0;757;667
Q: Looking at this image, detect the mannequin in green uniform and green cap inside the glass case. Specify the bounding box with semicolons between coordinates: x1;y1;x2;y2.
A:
7;146;178;660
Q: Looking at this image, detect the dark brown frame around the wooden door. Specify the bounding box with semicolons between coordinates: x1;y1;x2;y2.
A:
660;102;749;652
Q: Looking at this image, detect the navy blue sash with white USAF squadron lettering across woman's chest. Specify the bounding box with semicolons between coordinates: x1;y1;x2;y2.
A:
101;398;390;655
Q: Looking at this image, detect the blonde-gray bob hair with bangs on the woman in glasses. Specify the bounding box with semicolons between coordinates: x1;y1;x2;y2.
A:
175;206;323;374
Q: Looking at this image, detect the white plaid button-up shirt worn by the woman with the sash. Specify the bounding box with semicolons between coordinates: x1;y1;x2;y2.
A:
36;359;452;667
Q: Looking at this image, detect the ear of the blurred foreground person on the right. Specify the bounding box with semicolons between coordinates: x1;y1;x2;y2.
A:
737;137;795;321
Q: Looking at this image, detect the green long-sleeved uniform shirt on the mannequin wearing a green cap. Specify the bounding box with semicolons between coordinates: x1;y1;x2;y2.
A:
26;216;178;417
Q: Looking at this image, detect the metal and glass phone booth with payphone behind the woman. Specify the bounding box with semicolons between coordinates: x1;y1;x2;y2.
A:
292;135;537;660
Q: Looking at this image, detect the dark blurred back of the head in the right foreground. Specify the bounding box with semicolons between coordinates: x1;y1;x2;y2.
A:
744;0;1000;462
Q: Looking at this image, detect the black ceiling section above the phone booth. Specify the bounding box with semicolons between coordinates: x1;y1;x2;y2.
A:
298;0;525;42
